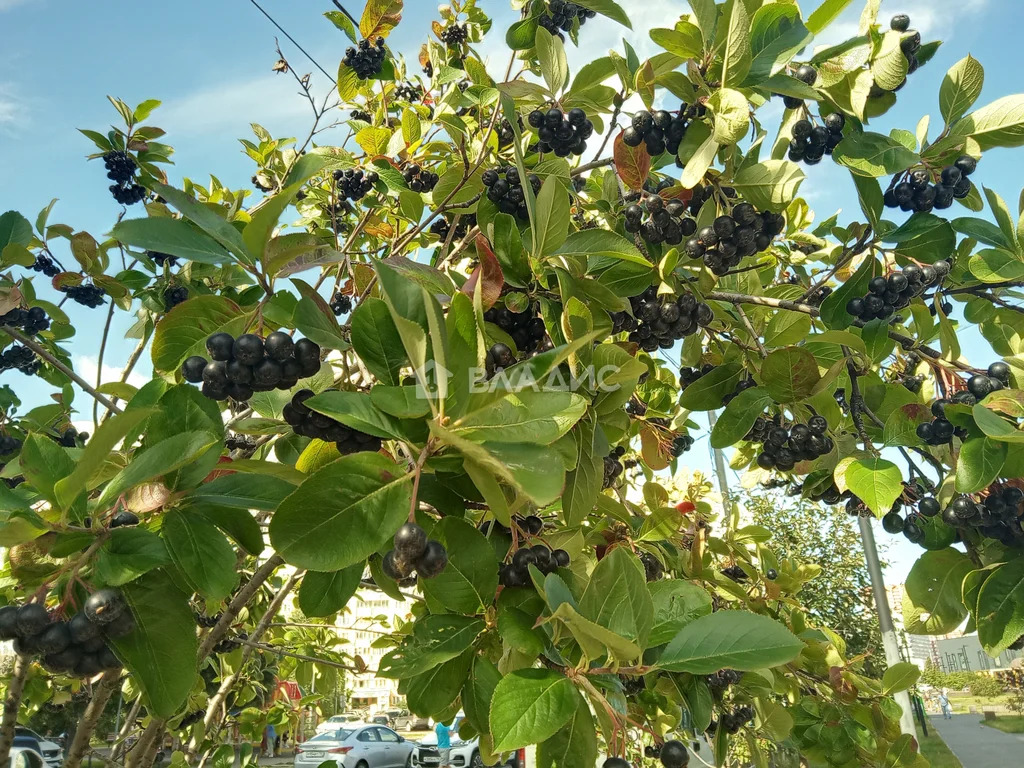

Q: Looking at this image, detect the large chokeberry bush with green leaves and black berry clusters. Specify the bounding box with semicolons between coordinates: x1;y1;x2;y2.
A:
0;0;1024;768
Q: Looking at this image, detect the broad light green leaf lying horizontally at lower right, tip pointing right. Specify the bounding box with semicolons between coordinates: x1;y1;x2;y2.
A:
657;610;804;675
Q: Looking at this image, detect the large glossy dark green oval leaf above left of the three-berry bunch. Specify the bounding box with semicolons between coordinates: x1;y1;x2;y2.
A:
270;454;413;571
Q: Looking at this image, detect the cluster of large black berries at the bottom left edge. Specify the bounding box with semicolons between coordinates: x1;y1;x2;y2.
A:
0;589;135;678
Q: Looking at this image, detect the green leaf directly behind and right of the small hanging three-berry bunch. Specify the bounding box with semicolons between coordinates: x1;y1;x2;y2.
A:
420;517;498;618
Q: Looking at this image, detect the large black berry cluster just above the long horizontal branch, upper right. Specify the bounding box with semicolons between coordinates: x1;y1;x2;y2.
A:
683;203;785;276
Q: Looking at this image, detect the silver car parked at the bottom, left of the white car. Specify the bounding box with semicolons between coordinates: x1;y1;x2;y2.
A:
295;723;413;768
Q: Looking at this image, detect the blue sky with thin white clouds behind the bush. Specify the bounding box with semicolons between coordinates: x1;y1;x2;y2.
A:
0;0;1024;582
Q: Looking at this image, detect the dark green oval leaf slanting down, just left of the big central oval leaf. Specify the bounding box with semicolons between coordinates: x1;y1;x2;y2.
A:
161;509;239;600
